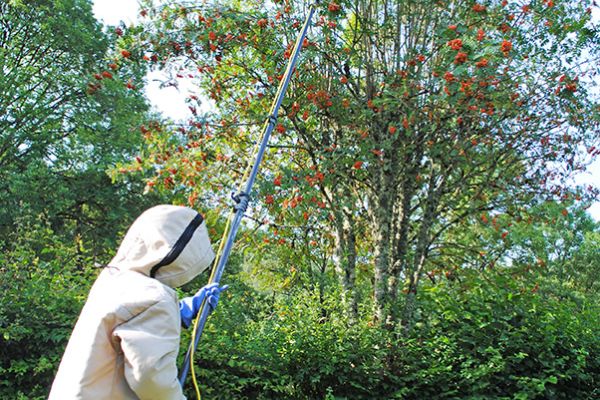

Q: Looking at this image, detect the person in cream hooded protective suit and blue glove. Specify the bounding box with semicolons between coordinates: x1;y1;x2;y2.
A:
49;205;223;400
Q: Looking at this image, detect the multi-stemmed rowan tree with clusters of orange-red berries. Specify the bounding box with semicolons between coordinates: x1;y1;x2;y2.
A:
115;0;600;328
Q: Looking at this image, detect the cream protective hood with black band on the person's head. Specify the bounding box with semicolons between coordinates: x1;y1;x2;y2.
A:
109;205;215;288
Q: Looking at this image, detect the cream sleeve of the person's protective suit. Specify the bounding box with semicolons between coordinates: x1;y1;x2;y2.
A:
113;300;185;400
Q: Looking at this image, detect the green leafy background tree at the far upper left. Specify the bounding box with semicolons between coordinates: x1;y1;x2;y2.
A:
0;0;154;252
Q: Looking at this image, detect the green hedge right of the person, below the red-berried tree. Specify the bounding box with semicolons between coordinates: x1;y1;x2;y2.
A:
190;272;600;399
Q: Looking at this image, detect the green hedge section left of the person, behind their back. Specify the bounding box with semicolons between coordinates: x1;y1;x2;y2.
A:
0;229;95;399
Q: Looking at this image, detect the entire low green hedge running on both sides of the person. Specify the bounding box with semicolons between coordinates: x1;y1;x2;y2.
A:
0;239;600;400
